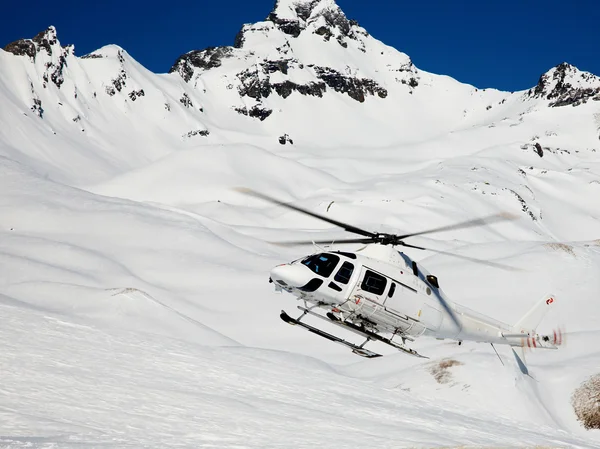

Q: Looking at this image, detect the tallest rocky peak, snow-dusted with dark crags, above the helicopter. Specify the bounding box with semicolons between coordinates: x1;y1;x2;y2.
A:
170;0;394;114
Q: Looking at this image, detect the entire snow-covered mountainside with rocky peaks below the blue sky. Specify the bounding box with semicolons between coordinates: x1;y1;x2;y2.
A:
0;0;600;448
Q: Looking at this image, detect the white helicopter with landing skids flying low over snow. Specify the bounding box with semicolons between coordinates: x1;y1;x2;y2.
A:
236;188;562;358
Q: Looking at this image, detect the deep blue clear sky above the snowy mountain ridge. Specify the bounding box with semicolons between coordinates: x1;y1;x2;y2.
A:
0;0;600;90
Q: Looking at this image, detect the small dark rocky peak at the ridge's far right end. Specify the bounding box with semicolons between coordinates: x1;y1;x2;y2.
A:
527;62;600;107
